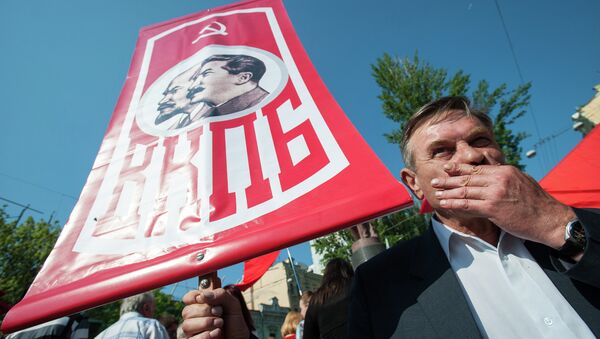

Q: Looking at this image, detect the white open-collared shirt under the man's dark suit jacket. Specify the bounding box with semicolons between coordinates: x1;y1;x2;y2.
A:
432;218;595;338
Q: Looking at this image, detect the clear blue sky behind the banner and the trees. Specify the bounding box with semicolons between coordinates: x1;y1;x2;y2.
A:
0;0;600;292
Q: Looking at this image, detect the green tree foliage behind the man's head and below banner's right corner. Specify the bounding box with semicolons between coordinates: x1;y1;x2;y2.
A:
315;53;531;262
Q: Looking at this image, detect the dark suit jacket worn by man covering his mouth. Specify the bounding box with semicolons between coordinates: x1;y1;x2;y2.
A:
348;209;600;339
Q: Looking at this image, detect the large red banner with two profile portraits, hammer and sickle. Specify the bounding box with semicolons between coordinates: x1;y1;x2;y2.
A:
2;0;411;332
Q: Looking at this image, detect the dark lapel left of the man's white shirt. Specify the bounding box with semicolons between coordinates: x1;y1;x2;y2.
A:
411;227;481;338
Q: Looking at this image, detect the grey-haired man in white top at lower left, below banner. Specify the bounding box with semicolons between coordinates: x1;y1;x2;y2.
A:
96;292;169;339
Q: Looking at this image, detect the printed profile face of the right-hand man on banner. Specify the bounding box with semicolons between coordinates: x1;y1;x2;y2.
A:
188;61;239;106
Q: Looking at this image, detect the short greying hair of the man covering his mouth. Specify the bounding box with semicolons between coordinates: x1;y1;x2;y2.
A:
400;96;494;169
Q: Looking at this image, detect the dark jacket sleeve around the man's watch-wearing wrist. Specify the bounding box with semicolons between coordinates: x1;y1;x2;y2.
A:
551;208;600;287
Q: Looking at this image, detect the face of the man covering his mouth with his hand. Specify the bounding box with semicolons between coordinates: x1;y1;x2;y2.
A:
402;111;504;209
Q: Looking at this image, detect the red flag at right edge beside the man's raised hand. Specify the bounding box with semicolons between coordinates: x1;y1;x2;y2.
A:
540;126;600;208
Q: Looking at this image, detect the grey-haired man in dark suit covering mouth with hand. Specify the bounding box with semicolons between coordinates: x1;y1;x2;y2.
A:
348;97;600;339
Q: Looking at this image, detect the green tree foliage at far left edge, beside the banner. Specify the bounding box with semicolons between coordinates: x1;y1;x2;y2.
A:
0;208;60;304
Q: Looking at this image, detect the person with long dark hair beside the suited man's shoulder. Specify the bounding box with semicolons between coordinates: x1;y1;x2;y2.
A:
303;258;354;339
